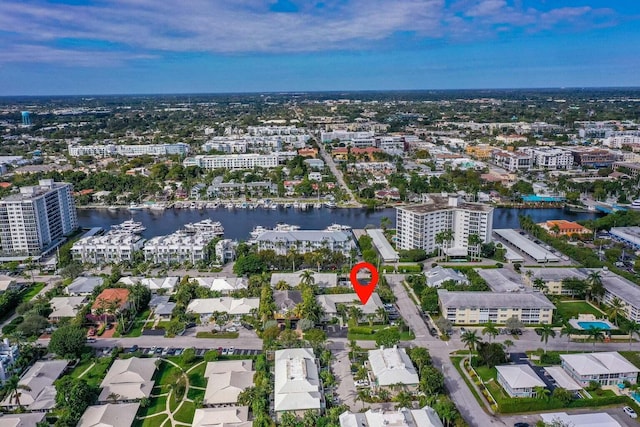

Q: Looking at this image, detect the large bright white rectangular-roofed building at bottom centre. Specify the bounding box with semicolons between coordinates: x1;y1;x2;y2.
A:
274;348;322;412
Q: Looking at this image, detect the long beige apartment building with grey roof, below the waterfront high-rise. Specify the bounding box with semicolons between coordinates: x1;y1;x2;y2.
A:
438;289;555;325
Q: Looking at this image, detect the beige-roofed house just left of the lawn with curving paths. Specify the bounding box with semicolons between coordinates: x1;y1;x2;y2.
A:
98;357;158;402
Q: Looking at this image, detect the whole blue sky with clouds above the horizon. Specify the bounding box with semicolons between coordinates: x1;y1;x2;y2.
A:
0;0;640;95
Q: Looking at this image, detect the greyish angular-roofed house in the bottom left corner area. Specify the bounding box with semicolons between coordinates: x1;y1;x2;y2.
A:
0;360;69;411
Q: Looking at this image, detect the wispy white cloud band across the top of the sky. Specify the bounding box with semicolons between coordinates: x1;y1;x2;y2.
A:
0;0;624;62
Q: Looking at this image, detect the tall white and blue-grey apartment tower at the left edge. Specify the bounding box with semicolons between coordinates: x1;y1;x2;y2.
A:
0;179;78;259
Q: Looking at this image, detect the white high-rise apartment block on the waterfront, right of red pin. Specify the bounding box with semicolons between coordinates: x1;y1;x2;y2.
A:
396;194;493;256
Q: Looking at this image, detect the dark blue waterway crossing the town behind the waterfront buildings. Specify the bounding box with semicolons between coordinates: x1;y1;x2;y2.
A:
78;208;599;240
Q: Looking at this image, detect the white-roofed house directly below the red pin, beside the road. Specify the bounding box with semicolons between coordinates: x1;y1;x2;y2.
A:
369;346;420;387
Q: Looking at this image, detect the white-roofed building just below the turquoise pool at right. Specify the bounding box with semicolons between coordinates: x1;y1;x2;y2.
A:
560;351;640;387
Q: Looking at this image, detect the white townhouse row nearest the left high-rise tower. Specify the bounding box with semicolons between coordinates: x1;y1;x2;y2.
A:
71;232;145;265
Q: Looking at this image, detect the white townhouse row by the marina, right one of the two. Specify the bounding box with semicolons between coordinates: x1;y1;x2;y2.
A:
143;231;216;264
